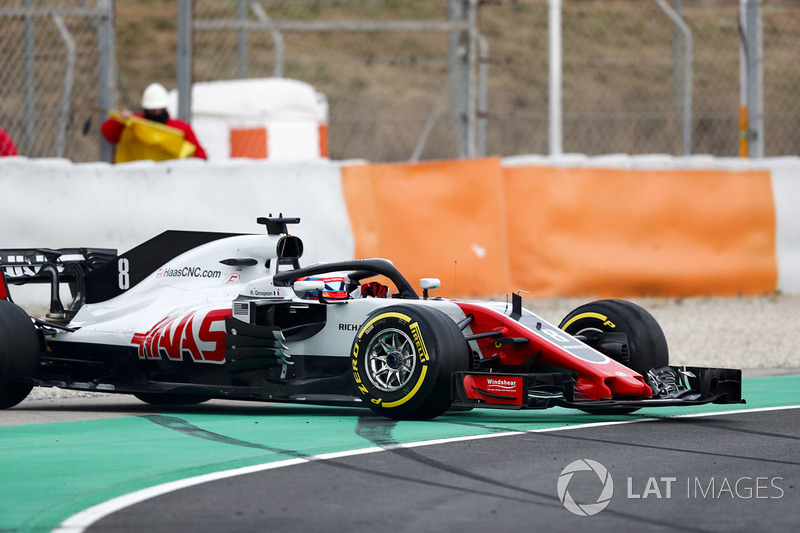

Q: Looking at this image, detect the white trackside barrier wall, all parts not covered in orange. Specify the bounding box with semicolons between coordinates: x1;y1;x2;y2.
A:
0;154;800;300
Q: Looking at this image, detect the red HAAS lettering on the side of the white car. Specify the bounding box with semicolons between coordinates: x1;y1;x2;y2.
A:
131;309;232;364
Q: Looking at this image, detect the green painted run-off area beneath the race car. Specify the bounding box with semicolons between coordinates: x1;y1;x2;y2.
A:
0;376;800;531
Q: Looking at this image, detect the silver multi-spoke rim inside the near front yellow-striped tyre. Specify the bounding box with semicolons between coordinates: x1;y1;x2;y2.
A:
366;329;417;392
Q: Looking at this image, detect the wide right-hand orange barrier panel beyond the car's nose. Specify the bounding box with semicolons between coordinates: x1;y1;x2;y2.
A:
503;167;777;297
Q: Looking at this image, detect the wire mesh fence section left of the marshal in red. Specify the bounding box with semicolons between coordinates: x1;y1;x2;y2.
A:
0;0;114;160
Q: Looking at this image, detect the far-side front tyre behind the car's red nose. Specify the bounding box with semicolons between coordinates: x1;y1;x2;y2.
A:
558;300;669;415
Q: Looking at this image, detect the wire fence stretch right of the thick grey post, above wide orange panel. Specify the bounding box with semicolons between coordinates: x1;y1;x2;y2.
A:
480;0;800;156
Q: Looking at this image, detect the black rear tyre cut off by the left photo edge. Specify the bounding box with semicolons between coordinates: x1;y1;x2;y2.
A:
0;300;42;409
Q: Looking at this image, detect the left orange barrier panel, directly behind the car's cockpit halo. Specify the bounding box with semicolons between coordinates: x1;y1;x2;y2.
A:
342;158;511;297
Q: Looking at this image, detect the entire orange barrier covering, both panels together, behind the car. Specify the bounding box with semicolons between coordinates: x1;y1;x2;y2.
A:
342;158;777;298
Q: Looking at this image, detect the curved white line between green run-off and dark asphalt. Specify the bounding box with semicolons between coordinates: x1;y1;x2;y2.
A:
53;405;800;533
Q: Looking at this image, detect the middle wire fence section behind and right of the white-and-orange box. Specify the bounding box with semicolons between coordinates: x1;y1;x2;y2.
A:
194;0;474;161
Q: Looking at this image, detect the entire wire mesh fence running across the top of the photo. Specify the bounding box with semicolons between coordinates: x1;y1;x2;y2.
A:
0;0;800;161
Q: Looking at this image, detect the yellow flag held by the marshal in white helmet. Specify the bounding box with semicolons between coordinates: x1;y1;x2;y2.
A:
108;111;197;163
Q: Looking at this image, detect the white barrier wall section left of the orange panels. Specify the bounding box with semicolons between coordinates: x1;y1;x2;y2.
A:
0;157;354;264
